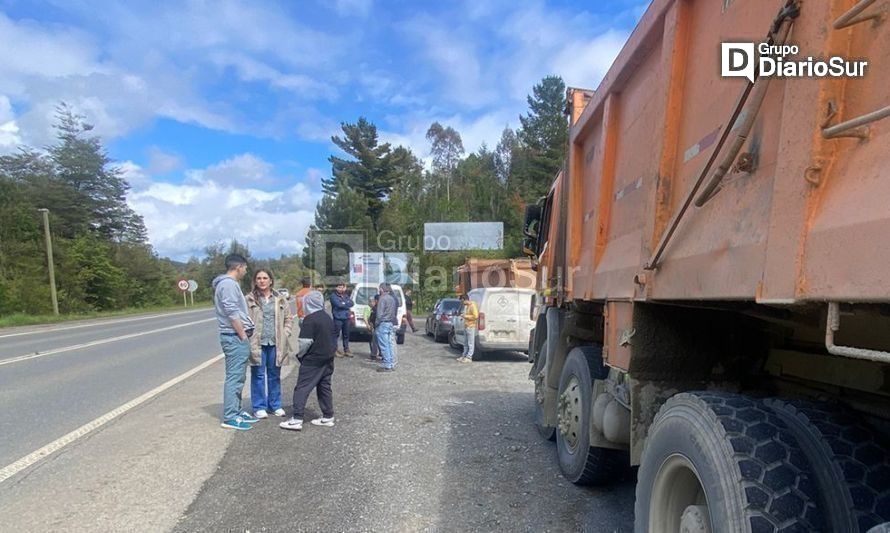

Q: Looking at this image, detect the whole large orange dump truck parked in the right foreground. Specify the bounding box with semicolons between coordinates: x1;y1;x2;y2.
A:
525;0;890;532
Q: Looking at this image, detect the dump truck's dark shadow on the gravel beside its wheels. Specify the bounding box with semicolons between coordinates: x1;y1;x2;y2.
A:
434;391;634;532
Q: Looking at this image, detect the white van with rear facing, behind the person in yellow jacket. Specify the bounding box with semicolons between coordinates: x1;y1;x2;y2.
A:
448;287;535;352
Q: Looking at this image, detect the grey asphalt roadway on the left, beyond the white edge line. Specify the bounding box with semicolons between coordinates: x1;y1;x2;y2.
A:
0;309;220;468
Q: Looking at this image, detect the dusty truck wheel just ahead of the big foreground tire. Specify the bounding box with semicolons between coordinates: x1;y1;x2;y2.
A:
556;346;629;485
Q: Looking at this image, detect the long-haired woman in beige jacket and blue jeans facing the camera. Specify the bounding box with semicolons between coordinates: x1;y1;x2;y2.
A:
247;269;294;418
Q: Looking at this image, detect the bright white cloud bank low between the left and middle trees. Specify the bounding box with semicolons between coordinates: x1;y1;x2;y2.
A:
122;154;321;260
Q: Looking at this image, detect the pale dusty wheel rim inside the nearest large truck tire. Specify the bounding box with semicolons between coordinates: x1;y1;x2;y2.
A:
649;454;711;533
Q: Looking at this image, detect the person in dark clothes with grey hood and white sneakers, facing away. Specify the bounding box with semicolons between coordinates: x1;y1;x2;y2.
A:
278;291;336;431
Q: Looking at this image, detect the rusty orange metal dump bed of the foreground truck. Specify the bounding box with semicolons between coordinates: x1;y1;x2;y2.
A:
560;0;890;304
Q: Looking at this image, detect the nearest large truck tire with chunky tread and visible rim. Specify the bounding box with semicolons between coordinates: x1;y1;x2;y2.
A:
634;392;825;533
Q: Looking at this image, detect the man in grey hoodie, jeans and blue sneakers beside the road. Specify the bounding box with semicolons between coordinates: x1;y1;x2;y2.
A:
213;254;257;431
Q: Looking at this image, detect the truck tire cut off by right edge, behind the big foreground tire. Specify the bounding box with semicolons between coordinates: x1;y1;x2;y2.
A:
764;399;890;532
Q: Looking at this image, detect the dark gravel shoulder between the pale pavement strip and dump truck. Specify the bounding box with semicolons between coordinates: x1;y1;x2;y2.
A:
175;334;633;532
